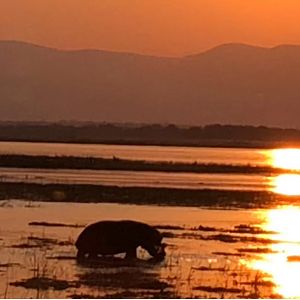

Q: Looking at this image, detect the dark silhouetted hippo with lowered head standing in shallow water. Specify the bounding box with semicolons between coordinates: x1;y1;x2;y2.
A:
75;220;165;260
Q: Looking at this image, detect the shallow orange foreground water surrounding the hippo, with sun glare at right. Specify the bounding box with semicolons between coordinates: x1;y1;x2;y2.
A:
0;200;300;298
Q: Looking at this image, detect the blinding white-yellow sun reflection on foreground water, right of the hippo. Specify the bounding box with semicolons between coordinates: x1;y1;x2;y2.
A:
247;207;300;298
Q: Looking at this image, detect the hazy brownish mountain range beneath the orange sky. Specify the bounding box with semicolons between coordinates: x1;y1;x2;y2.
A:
0;41;300;128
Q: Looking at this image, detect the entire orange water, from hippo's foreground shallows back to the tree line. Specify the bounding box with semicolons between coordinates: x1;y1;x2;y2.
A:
0;143;300;298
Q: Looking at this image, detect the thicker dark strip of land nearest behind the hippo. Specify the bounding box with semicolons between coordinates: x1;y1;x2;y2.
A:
0;182;300;209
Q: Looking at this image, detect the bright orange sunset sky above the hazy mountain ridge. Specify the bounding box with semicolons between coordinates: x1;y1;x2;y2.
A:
0;0;300;56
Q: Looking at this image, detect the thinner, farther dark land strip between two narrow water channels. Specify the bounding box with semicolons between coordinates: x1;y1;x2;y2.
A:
0;154;288;175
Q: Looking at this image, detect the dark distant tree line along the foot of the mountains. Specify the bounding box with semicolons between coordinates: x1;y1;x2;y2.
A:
0;122;300;146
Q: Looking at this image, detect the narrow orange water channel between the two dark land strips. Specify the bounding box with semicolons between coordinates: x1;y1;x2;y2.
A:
0;168;276;191
